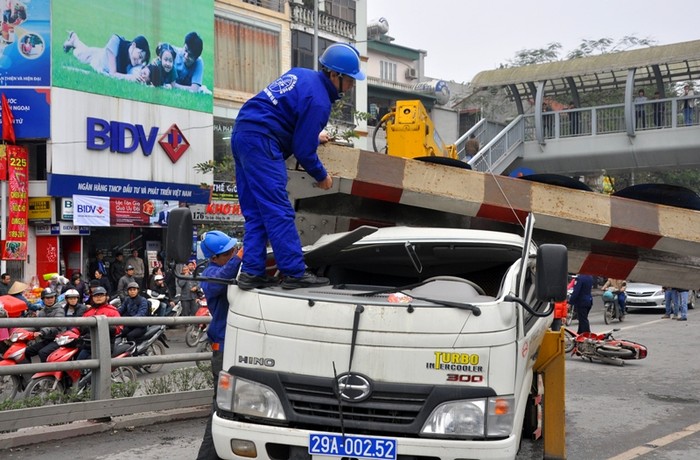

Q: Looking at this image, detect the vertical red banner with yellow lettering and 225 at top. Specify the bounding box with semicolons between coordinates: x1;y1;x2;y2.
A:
2;145;29;260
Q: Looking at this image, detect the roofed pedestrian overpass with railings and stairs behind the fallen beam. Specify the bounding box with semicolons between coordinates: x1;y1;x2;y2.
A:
457;40;700;175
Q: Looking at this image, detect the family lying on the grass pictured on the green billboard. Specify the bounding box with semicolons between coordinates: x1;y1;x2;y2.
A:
63;31;211;93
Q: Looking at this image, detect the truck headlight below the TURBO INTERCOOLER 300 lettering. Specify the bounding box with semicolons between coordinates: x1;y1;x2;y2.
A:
421;396;515;438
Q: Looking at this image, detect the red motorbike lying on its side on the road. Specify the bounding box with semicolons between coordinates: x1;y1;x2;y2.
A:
564;328;647;366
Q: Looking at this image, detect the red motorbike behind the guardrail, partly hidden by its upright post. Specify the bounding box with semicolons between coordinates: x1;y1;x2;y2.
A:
24;330;136;401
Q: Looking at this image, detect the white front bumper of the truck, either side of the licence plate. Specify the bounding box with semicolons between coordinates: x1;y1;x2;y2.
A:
212;414;518;460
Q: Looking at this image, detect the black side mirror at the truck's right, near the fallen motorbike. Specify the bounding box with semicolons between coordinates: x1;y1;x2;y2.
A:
535;244;569;302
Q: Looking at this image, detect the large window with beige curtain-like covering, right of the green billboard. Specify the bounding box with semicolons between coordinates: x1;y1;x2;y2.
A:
214;16;282;93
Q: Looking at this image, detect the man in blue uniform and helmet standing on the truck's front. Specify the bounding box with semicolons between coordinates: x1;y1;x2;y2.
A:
231;43;365;290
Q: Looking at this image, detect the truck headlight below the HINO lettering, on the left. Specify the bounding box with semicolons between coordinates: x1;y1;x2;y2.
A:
216;371;287;420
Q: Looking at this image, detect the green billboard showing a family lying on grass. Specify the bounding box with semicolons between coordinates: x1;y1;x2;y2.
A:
51;0;214;113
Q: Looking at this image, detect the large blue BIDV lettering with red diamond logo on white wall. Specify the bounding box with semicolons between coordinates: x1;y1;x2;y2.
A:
87;117;190;163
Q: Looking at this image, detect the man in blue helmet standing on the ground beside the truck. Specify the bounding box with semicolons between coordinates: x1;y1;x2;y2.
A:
197;230;243;460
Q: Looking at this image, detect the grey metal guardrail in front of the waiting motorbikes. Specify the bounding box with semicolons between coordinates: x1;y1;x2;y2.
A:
0;316;213;432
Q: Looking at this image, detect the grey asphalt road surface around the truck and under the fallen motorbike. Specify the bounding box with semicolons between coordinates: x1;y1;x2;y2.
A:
0;296;700;460
